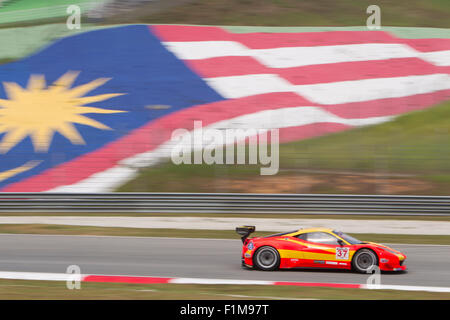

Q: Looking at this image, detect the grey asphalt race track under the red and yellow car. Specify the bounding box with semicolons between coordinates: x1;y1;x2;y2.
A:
0;234;450;287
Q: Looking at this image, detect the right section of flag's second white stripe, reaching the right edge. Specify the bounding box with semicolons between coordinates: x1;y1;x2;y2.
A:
295;74;450;104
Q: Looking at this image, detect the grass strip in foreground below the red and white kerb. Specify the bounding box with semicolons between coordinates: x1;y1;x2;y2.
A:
0;280;450;300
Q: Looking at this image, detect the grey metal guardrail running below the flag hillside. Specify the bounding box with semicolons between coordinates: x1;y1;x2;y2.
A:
0;193;450;216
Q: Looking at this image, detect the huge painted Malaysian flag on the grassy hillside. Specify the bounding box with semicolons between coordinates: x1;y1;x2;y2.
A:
0;25;450;192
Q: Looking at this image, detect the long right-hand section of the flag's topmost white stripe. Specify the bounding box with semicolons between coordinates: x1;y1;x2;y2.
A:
251;43;419;68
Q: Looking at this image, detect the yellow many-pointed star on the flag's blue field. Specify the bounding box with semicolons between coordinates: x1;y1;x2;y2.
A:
0;71;127;153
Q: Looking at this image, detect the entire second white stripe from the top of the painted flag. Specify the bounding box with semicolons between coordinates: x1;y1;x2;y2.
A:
205;74;450;105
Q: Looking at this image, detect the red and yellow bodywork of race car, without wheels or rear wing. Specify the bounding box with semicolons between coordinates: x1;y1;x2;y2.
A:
242;228;406;271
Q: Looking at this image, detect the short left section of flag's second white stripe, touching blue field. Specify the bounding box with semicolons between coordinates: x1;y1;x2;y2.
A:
205;74;295;99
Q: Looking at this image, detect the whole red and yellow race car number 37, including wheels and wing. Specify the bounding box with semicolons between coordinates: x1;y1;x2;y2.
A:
236;226;406;273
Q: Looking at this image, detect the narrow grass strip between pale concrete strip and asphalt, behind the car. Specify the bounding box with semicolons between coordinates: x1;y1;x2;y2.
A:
0;224;450;245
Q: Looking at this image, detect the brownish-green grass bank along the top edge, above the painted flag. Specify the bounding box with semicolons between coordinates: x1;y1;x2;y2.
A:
107;0;450;28
